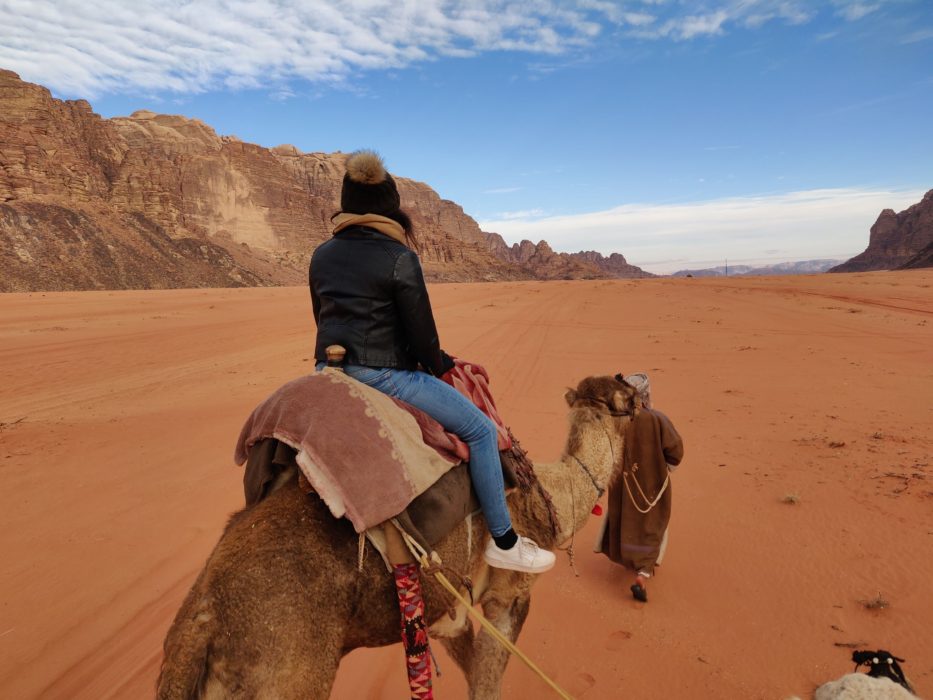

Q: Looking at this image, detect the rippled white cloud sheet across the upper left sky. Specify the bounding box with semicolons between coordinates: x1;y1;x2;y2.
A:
0;0;624;96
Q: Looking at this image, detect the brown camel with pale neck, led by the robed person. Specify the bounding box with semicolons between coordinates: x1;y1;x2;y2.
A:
157;376;639;700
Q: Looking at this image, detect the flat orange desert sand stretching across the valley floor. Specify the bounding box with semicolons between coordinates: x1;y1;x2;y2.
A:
0;271;933;700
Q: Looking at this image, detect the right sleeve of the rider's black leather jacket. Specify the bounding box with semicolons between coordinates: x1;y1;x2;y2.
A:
394;251;449;377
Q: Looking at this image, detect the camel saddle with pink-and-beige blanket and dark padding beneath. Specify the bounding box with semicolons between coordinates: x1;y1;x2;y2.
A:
234;366;537;551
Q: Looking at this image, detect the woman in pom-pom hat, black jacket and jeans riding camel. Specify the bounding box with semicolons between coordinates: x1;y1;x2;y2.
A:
309;151;555;573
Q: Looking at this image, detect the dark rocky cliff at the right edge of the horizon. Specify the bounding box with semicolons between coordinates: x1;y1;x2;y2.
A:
830;190;933;272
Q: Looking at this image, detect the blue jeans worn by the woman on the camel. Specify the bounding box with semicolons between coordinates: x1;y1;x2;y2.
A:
336;365;512;537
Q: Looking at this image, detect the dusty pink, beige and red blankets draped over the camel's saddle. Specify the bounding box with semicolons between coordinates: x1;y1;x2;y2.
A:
234;360;512;533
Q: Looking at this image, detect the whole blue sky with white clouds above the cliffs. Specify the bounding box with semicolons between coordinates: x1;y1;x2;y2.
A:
0;0;933;272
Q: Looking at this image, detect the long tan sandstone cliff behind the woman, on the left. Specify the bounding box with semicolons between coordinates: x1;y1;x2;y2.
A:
0;70;652;291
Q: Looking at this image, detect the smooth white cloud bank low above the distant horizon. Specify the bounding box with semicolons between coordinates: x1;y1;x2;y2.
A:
480;189;924;273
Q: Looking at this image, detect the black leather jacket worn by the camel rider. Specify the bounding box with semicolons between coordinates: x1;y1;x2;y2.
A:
308;226;453;376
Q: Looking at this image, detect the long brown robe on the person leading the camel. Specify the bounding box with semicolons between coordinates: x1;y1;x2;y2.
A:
598;408;684;574
